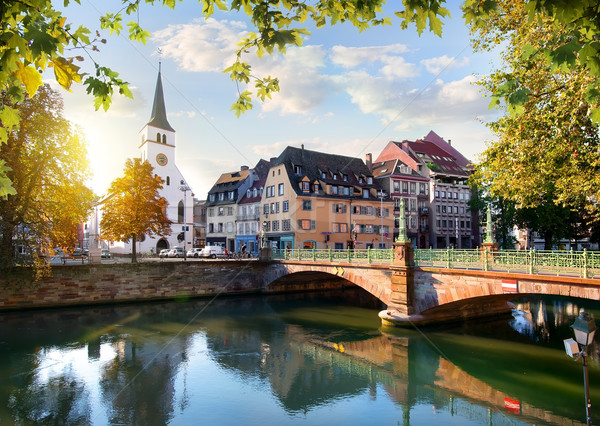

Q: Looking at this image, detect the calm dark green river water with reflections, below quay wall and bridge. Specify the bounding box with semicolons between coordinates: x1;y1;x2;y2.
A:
0;292;600;425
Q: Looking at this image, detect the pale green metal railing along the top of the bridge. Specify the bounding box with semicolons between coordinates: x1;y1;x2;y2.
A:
272;248;600;279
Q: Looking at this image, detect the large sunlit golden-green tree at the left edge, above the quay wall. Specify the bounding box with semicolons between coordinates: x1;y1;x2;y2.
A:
0;86;93;269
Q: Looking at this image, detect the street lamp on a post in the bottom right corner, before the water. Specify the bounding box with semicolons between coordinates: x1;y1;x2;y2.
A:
564;311;596;425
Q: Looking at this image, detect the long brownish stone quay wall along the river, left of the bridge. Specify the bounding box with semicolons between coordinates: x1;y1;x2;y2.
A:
0;260;350;311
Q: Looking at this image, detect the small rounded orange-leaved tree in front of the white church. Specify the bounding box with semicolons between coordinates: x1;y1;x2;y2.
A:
100;158;171;263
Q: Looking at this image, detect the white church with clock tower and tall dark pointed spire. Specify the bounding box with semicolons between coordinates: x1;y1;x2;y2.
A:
89;64;194;255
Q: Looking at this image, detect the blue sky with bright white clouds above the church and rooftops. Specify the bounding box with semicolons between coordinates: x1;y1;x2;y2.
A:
45;0;498;199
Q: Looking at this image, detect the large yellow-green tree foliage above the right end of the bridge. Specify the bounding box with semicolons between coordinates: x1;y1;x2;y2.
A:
474;0;600;215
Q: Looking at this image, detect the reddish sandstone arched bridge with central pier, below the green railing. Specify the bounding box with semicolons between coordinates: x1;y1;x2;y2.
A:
263;243;600;326
